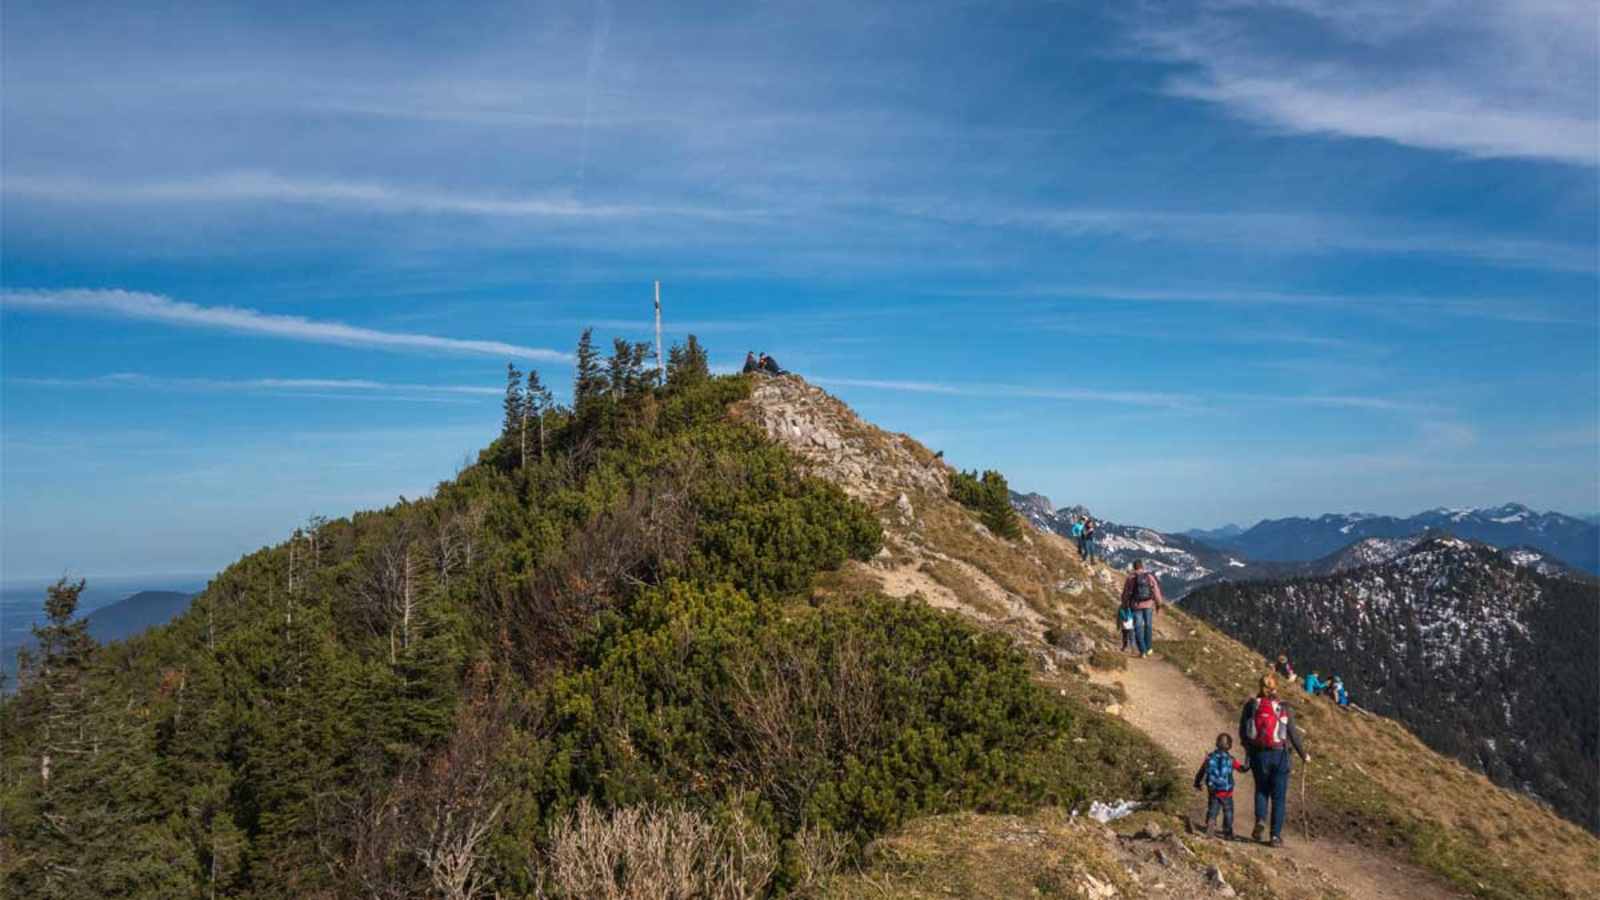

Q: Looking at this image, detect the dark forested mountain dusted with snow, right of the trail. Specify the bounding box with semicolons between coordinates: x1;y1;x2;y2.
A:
1184;534;1600;830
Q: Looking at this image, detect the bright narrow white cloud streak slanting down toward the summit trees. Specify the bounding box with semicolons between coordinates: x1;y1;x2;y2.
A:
0;290;571;362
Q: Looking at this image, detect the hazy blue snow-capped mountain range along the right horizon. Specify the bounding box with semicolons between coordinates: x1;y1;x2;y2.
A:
1213;503;1600;573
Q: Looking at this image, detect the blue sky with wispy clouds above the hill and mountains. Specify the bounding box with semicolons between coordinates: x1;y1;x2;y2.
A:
0;0;1600;578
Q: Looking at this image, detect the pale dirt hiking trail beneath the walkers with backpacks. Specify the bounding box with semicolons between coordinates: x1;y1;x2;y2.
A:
1091;633;1464;900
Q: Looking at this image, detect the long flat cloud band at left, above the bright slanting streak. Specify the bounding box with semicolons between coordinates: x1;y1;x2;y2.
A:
3;171;762;221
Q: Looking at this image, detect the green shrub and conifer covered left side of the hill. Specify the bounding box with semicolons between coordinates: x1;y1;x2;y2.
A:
0;333;1170;898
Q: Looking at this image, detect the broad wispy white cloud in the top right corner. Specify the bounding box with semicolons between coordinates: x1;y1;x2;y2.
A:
1136;0;1600;167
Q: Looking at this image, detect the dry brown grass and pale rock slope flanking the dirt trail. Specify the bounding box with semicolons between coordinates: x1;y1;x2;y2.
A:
736;376;1600;900
